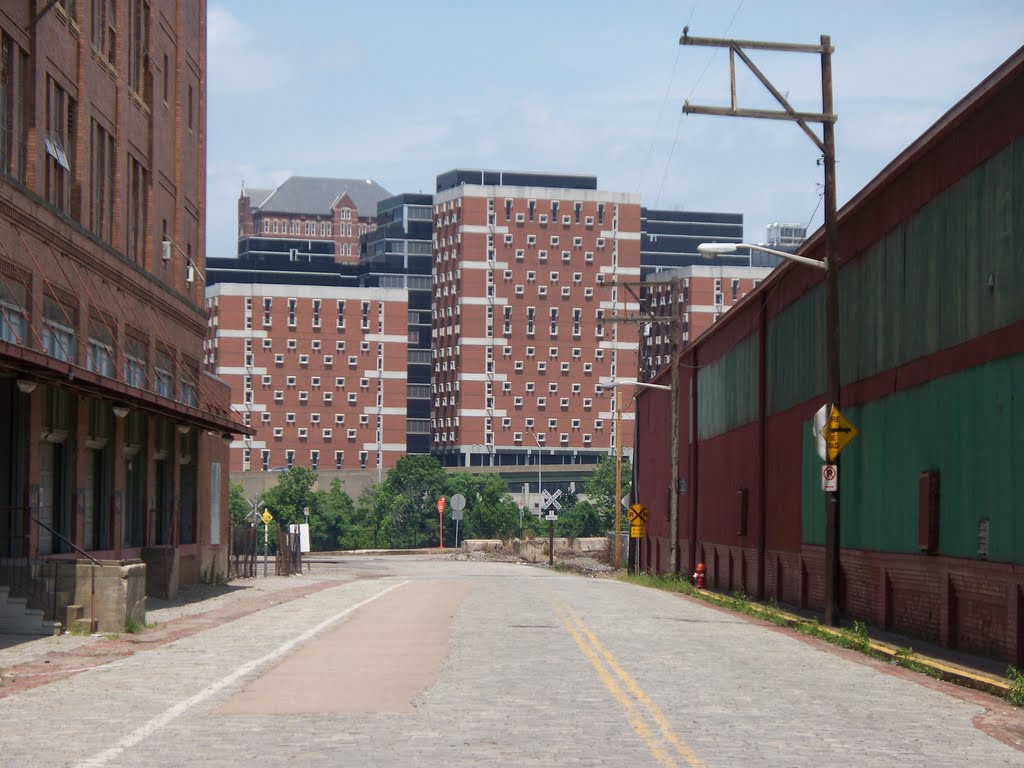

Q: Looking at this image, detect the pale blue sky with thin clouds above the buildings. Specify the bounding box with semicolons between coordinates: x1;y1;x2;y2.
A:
206;0;1024;257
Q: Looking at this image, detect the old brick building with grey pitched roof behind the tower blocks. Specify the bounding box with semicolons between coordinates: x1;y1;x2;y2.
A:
239;176;390;264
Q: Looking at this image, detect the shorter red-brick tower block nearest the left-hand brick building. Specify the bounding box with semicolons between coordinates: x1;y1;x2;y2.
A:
207;282;409;472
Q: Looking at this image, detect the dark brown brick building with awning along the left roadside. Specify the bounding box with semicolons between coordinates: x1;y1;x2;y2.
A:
0;0;242;630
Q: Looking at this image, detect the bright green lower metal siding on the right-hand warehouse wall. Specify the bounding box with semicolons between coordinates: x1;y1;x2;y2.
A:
802;355;1024;563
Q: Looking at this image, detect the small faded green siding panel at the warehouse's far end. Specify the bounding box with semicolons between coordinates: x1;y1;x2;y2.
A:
697;335;759;440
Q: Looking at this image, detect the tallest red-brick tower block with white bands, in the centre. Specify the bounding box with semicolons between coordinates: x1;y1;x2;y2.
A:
431;169;640;473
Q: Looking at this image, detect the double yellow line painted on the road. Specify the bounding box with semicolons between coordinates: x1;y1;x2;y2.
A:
555;605;703;768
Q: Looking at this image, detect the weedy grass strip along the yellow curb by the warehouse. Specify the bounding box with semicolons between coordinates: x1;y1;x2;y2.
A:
617;571;1024;707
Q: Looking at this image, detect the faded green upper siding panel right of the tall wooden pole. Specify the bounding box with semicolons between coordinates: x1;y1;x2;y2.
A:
839;139;1024;387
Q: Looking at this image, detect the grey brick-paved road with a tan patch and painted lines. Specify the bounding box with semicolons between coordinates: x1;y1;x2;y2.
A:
0;557;1024;768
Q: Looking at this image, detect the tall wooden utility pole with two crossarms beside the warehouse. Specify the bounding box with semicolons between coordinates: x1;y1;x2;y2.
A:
679;33;841;627
